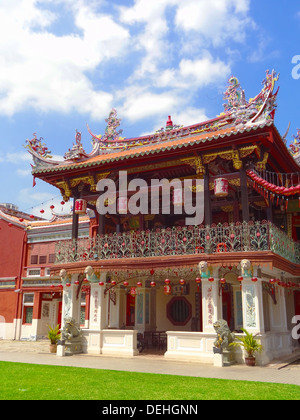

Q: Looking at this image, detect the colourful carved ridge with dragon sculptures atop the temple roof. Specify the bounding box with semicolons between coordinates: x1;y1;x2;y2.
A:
25;70;292;167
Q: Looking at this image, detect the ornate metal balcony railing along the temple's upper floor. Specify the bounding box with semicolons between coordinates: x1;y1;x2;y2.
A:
55;221;300;264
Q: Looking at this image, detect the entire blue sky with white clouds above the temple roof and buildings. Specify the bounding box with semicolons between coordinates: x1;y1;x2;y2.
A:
0;0;300;220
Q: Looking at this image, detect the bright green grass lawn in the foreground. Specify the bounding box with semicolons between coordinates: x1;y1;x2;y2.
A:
0;362;300;401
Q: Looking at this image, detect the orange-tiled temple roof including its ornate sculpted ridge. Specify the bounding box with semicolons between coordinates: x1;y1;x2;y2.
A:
25;70;292;174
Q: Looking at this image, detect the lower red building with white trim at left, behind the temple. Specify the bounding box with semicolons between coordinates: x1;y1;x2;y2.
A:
0;204;92;340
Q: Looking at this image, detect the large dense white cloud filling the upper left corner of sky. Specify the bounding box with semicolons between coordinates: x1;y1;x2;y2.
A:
0;0;128;118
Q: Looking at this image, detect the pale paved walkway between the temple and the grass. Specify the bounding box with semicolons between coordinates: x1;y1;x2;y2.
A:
0;340;300;392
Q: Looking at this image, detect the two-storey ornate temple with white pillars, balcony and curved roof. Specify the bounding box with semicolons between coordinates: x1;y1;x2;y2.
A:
19;71;300;364
